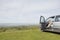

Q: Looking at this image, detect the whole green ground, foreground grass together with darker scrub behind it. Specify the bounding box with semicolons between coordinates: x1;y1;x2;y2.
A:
0;26;60;40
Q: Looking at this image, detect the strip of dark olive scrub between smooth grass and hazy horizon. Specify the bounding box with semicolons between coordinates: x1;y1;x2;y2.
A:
0;26;38;32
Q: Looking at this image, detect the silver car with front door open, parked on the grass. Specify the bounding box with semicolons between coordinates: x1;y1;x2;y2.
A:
40;15;60;33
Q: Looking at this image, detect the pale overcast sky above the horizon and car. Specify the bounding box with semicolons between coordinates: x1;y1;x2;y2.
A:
0;0;60;24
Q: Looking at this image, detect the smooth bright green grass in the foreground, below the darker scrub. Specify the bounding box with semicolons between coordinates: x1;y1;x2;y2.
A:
0;29;60;40
